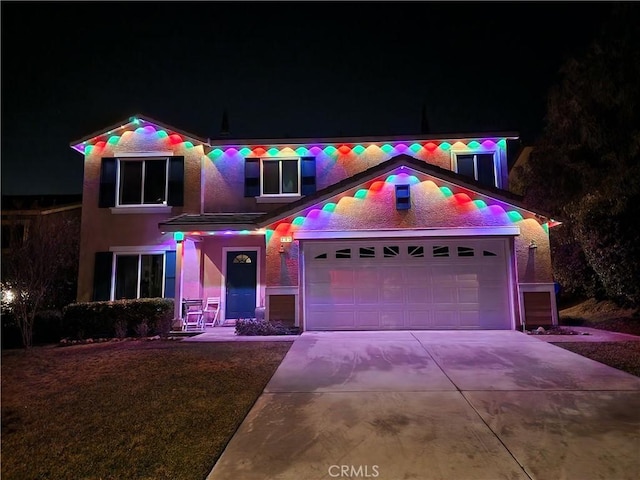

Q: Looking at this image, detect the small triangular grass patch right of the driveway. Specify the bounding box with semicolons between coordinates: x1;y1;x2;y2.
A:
554;342;640;377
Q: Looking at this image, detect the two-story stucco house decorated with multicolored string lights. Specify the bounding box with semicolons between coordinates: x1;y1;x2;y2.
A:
71;115;557;330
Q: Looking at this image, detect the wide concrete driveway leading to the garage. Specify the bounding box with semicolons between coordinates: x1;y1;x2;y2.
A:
208;331;640;480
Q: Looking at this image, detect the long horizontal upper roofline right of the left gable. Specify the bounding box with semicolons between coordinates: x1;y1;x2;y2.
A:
208;131;520;147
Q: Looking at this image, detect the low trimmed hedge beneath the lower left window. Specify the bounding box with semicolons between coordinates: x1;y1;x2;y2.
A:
60;298;173;339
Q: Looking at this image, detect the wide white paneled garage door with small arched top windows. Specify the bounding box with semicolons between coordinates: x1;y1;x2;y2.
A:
302;238;512;330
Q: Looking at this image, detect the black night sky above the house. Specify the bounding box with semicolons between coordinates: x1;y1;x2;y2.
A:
0;1;612;194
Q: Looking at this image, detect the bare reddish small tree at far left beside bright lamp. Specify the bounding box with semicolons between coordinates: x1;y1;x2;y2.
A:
2;215;79;348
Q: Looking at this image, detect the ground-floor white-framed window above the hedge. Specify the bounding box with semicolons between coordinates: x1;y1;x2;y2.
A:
112;253;165;300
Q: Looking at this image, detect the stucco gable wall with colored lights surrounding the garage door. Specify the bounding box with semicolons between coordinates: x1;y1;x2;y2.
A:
267;175;552;286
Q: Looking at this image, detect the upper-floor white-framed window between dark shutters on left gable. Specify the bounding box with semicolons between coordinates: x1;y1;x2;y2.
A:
118;158;168;205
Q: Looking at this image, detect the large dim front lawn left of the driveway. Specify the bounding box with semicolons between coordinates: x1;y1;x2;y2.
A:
1;341;291;480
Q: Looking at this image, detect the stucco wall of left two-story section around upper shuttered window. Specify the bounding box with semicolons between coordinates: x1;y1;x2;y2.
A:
77;131;204;301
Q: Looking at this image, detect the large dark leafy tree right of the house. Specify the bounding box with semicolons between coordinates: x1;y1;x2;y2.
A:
520;3;640;305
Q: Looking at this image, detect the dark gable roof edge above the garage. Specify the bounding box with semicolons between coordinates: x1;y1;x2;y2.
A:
257;154;551;227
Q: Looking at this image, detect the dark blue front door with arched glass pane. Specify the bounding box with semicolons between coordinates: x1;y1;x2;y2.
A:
225;250;258;319
